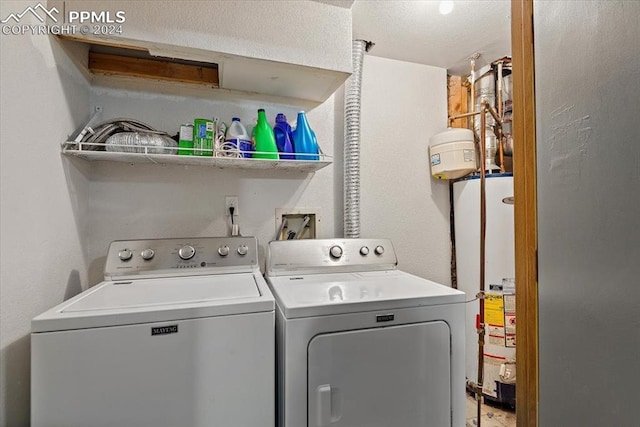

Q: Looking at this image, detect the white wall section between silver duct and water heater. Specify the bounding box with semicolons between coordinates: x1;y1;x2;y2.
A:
360;56;451;285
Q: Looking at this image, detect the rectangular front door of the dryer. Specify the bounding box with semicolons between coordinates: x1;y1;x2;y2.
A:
307;321;451;427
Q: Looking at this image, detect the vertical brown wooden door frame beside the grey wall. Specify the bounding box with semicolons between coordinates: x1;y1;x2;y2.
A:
511;0;538;427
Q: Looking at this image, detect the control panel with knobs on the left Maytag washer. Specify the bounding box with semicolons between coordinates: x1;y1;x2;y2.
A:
105;237;258;278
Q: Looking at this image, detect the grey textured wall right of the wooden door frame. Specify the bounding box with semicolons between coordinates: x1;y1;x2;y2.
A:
536;0;640;426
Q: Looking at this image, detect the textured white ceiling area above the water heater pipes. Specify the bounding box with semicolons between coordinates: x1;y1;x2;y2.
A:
316;0;511;75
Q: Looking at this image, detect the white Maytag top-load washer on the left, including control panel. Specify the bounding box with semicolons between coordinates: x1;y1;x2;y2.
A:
31;237;275;427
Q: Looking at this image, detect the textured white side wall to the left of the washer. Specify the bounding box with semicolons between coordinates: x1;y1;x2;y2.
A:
0;1;89;427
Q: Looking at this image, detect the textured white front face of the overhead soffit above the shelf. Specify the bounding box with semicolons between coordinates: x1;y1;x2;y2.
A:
49;0;351;72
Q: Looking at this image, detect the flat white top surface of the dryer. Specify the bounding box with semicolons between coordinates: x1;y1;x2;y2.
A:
269;270;465;318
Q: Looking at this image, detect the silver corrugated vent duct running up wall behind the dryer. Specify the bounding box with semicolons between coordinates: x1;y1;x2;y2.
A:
344;40;373;238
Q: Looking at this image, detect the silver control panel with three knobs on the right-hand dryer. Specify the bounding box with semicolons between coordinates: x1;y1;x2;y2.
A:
267;239;398;276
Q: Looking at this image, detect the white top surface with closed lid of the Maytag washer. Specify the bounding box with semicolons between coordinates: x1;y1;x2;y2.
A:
32;273;275;332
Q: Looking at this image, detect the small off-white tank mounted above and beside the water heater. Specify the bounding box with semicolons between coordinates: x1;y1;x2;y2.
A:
429;128;478;179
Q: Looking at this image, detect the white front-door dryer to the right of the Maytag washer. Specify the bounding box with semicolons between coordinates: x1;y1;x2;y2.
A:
267;239;466;427
